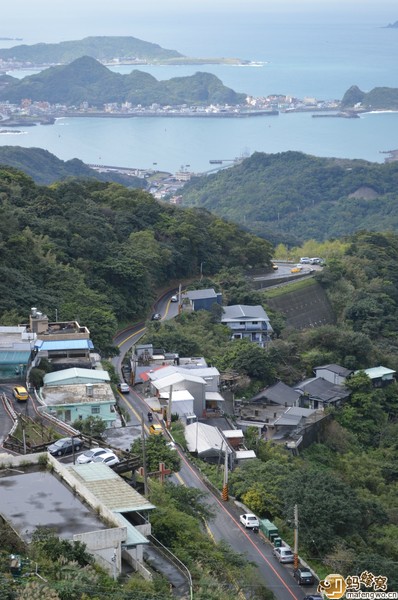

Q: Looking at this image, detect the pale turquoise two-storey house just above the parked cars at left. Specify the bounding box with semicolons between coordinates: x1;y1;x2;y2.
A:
38;368;118;427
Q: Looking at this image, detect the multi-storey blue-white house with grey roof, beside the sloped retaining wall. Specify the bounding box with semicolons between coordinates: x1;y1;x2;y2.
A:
221;304;273;348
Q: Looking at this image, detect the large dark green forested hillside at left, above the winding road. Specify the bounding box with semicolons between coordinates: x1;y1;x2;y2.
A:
0;167;272;352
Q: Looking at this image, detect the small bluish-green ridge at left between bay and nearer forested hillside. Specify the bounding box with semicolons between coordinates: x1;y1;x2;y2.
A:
0;146;146;189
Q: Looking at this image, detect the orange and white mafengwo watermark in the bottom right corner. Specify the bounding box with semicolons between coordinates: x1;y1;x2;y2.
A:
317;571;398;600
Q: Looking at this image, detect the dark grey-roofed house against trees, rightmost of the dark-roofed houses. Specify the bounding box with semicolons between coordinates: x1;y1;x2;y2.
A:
295;377;351;409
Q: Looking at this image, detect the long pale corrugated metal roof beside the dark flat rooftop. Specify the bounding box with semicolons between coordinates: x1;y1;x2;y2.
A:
68;463;155;513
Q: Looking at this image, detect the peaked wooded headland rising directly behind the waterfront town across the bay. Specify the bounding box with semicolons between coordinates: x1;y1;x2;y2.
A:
0;56;246;109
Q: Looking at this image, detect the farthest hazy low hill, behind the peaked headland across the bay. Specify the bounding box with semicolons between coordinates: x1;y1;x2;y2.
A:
0;36;182;65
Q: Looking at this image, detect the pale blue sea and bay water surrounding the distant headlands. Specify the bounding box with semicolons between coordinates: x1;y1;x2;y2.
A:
0;2;398;173
